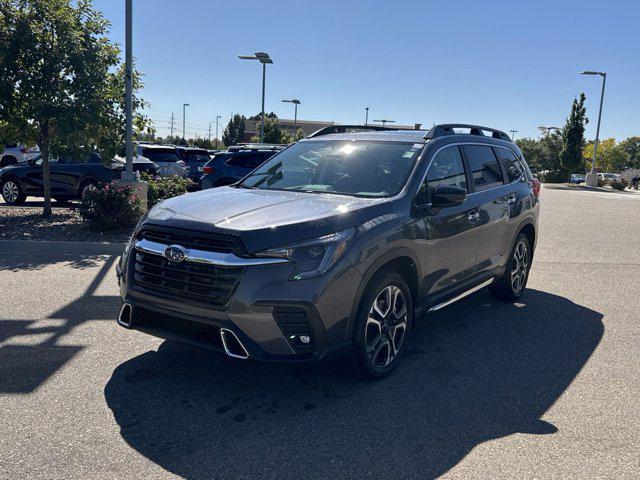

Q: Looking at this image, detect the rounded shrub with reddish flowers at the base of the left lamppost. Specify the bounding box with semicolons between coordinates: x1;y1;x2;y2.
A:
78;185;142;231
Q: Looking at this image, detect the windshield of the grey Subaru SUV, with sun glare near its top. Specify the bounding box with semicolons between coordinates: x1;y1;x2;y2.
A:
240;140;422;197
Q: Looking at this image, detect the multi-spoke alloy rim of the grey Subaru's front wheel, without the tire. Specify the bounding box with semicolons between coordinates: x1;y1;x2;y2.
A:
365;285;407;368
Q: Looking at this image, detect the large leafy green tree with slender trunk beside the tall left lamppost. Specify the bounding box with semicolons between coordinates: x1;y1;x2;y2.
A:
0;0;144;216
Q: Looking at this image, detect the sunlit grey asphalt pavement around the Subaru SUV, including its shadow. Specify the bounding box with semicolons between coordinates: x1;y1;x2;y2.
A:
0;189;640;479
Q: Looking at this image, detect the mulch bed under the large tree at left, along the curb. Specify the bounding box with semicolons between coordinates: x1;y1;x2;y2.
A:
0;206;131;243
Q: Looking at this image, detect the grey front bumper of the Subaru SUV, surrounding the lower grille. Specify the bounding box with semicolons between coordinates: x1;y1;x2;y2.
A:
117;249;361;362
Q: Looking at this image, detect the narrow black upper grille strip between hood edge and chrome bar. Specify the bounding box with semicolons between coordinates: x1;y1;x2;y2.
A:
138;227;243;254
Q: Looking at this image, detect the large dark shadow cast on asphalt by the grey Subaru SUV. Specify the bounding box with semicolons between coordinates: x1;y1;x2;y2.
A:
104;290;604;479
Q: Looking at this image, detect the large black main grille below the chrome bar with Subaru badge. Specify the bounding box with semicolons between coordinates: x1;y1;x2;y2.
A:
132;251;242;310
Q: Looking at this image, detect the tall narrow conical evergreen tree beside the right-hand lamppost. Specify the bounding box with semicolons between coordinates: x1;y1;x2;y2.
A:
560;93;589;178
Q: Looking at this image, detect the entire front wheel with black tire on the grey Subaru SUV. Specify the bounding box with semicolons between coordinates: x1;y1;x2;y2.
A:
351;270;413;379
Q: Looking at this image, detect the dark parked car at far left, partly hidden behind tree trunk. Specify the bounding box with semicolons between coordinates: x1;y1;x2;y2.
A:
0;154;120;205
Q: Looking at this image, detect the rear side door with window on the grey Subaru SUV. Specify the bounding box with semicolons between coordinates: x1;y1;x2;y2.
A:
462;144;513;271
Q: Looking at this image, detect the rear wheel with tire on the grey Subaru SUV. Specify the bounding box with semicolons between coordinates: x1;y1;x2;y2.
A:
489;233;532;302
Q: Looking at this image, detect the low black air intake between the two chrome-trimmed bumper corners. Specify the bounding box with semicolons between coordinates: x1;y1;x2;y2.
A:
134;306;222;348
